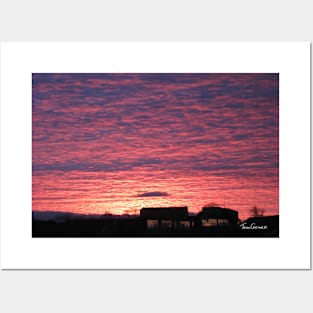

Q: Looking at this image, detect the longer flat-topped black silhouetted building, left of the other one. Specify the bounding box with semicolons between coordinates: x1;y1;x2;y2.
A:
140;207;193;230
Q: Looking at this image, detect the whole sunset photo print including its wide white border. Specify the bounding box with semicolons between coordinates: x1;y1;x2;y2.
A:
1;43;310;269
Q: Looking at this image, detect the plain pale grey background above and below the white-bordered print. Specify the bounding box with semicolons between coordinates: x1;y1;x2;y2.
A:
0;1;312;312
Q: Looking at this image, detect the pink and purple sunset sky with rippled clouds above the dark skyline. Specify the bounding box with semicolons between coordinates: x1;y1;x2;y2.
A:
32;73;279;219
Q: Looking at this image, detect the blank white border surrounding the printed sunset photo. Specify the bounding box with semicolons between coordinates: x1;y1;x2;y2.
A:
1;43;311;269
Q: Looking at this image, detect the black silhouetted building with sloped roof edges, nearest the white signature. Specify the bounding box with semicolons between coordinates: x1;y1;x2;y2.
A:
198;207;238;227
